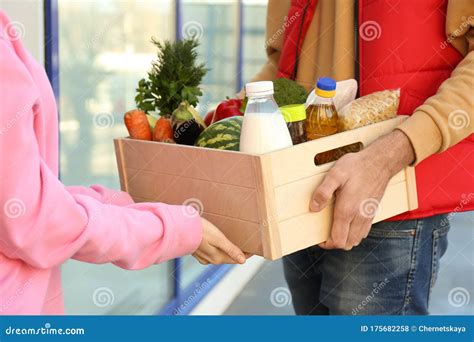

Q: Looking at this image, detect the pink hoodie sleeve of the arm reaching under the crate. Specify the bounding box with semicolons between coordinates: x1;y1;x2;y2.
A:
0;39;202;269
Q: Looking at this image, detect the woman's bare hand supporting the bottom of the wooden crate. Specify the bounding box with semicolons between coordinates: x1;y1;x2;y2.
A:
193;218;246;265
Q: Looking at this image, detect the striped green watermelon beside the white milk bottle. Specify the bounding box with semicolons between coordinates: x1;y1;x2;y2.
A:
195;116;243;151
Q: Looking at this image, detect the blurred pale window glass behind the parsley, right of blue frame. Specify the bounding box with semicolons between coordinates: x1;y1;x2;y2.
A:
58;0;175;314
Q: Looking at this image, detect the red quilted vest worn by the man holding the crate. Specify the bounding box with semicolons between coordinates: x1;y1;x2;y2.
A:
279;0;474;220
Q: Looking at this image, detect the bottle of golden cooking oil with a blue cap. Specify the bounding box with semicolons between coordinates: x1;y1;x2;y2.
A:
305;77;337;140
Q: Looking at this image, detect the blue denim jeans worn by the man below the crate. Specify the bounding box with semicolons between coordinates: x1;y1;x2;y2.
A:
283;215;449;315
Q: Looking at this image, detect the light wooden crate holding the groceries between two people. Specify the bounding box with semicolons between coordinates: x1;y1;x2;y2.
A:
115;117;418;260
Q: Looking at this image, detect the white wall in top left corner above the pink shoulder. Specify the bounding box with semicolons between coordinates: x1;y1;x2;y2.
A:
0;0;44;64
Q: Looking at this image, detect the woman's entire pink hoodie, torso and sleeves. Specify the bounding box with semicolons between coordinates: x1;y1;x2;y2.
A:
0;11;202;314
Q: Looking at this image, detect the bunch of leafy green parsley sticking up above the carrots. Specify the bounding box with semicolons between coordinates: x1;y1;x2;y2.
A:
135;38;208;117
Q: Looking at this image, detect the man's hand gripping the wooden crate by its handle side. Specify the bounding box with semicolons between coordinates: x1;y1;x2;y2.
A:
310;130;415;250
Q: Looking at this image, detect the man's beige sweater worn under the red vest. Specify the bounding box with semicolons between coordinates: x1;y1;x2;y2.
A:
254;0;474;163
